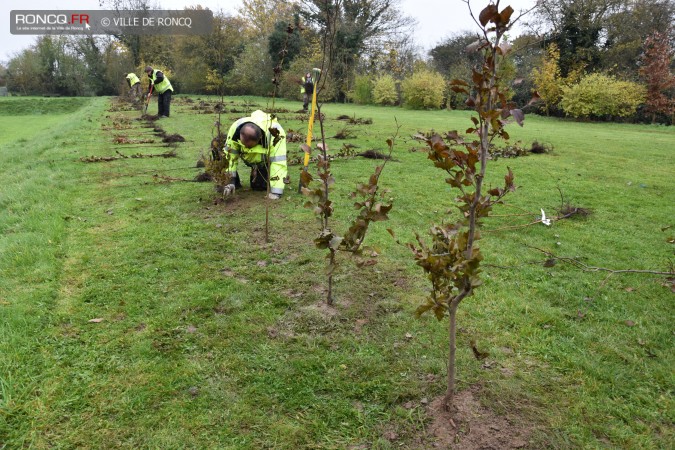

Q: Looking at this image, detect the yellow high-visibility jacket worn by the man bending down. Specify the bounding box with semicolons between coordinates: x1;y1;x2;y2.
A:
225;110;288;195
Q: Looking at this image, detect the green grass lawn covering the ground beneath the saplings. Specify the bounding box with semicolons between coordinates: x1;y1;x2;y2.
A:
0;96;675;449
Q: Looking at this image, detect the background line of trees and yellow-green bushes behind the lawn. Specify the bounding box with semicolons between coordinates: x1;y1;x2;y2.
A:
0;0;675;123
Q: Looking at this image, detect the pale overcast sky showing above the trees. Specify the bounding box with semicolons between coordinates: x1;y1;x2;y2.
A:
0;0;536;62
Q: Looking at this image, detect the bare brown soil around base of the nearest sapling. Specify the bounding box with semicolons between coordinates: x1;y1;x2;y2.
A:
427;386;532;450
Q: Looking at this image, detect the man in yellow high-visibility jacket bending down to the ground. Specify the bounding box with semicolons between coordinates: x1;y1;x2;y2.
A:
223;110;288;200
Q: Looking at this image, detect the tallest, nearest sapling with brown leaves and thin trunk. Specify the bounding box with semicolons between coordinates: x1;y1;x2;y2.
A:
407;1;524;409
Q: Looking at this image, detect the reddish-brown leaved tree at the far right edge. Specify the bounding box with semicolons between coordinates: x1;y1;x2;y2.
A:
640;32;675;123
